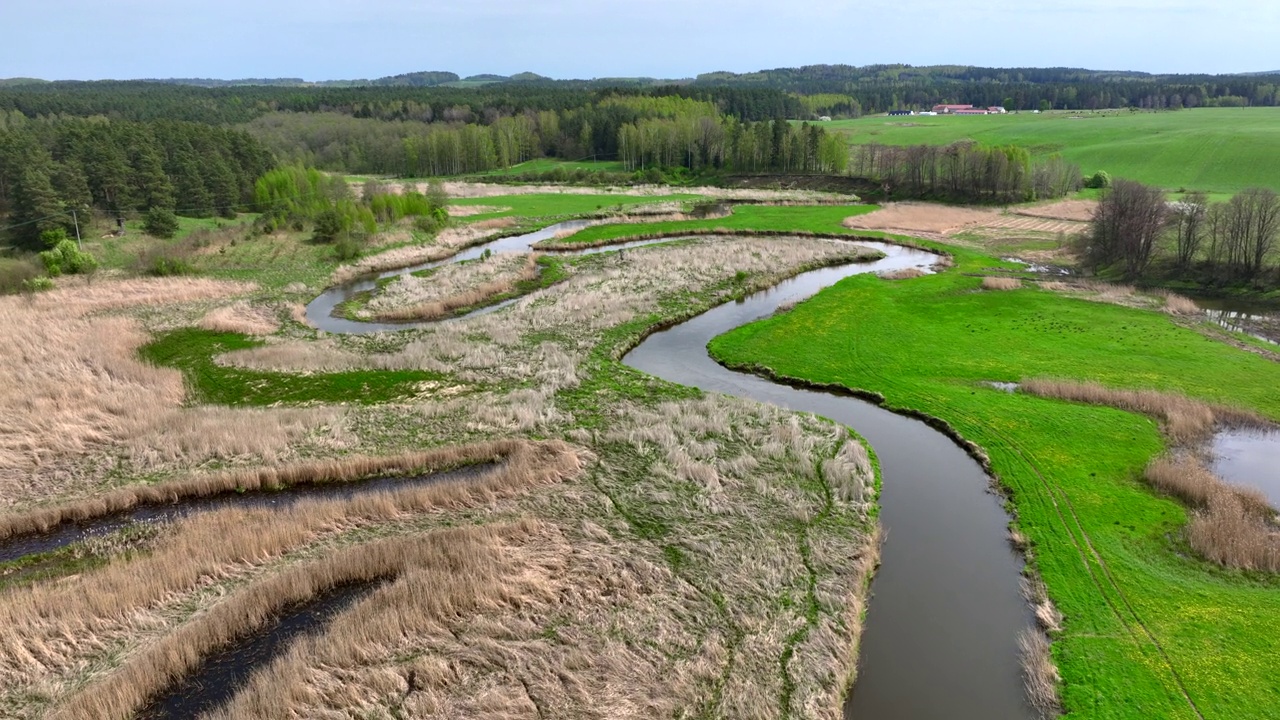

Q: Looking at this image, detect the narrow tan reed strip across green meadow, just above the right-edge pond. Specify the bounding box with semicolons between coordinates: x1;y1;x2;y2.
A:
1020;378;1267;445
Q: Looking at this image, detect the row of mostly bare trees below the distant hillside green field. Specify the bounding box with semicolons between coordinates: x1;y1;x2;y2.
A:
850;141;1083;202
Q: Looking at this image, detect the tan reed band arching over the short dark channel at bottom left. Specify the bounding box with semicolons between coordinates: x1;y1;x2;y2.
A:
49;521;536;720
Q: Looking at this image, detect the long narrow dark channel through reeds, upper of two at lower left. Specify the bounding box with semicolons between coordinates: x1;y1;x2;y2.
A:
0;462;494;562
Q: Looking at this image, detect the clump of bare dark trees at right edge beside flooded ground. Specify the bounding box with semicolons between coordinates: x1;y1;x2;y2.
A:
1082;179;1280;286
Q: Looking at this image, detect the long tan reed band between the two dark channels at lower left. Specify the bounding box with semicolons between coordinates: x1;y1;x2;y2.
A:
0;441;581;687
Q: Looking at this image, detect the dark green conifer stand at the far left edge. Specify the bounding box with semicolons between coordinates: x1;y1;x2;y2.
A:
0;117;275;249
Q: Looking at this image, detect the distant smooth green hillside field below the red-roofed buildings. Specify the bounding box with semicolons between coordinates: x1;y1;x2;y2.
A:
823;108;1280;193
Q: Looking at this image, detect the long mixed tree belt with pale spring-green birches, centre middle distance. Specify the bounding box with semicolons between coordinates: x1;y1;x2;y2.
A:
244;94;849;177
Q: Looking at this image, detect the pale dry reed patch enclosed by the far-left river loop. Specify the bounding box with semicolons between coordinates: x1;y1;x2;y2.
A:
357;252;539;322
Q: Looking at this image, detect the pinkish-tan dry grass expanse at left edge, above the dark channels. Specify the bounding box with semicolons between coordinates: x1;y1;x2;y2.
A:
0;278;257;503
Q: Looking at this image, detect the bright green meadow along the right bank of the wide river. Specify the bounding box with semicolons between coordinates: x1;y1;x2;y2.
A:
712;230;1280;719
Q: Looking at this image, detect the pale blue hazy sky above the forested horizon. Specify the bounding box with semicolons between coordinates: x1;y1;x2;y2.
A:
0;0;1280;81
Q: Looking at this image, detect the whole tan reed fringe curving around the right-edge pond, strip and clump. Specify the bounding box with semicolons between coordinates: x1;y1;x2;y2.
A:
1020;379;1280;573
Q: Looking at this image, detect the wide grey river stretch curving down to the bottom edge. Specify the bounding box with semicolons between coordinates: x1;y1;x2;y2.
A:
623;248;1036;720
